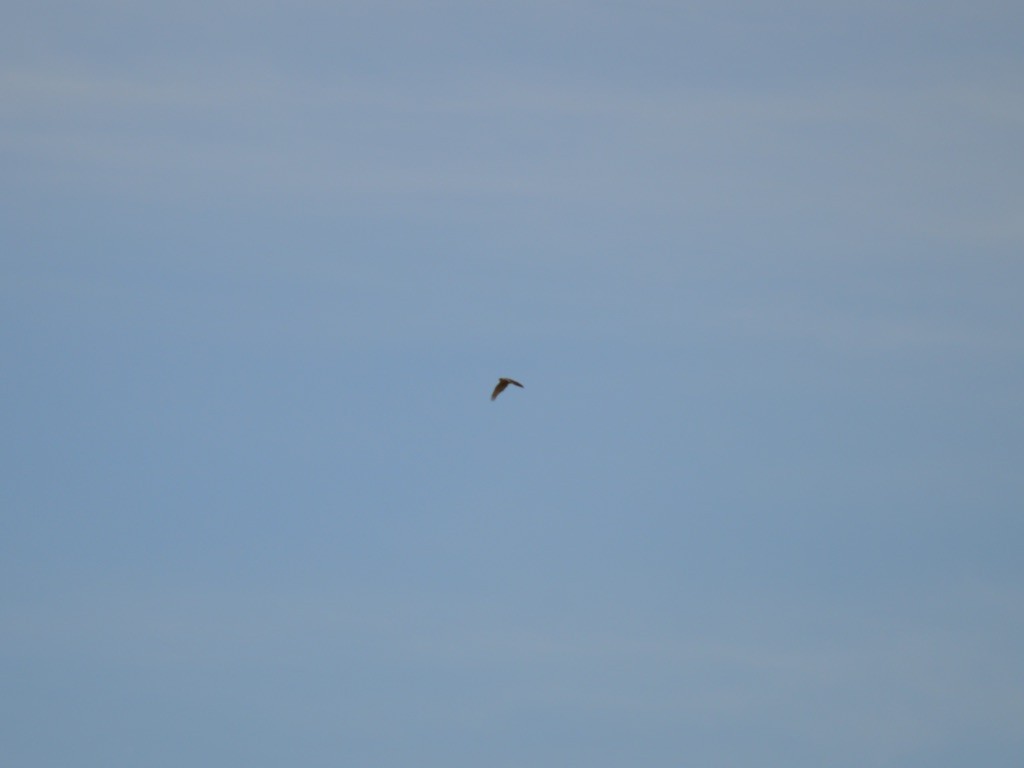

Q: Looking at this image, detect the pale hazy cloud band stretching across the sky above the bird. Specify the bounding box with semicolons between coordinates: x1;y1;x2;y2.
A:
6;63;1021;244
